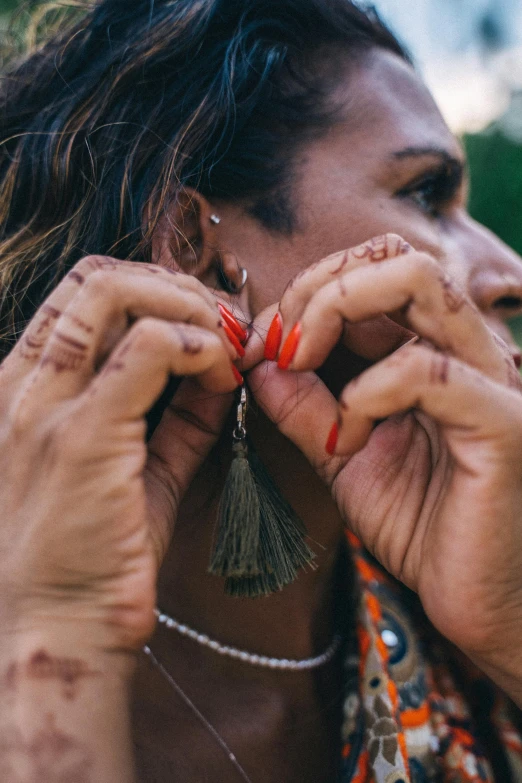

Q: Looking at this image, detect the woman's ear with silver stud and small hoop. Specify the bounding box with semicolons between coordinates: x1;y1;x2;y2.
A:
148;188;243;290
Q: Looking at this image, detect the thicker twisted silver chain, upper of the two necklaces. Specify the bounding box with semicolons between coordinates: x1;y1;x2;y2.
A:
155;609;342;672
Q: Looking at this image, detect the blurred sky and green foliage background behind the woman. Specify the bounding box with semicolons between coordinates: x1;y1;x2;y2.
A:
0;0;522;344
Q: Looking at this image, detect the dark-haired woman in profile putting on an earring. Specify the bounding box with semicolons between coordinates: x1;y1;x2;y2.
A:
0;0;522;783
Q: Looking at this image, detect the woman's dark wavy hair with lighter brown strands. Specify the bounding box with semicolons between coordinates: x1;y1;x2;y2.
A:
0;0;408;343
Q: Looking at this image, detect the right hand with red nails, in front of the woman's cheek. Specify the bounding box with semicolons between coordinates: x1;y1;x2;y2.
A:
249;235;522;697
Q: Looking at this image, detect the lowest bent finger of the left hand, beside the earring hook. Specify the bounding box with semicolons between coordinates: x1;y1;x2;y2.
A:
84;318;239;421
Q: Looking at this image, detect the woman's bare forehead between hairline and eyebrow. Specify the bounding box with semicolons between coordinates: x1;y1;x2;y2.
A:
332;49;462;163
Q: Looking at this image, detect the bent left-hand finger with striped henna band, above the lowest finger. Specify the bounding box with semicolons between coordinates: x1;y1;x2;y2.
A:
19;267;237;406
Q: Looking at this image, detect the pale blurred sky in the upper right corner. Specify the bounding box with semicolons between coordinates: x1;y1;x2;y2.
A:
374;0;522;133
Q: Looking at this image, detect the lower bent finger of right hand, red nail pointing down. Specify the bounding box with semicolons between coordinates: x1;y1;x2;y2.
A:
330;344;522;460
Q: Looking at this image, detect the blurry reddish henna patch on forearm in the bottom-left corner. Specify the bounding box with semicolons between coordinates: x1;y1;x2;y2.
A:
0;713;93;783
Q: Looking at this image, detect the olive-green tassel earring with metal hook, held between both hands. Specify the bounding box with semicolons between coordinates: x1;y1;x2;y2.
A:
209;386;315;598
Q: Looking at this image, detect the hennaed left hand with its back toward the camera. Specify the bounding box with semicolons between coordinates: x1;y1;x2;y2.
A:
0;257;238;649
